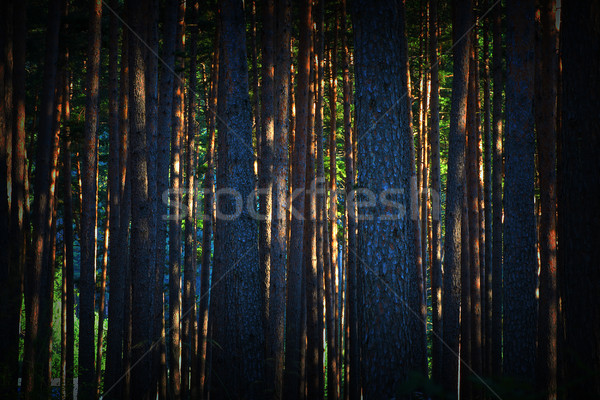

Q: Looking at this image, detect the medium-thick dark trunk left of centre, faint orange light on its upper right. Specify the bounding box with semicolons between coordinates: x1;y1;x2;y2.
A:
128;2;155;399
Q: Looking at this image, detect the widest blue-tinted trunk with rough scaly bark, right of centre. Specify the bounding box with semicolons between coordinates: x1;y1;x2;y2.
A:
349;1;425;399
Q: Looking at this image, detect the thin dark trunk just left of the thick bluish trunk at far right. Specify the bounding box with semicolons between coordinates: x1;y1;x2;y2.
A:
492;0;504;376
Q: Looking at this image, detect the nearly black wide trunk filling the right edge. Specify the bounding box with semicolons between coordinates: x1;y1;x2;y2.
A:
558;3;600;398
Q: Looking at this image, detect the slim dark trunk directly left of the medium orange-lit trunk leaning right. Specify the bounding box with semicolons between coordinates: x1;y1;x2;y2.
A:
429;0;443;383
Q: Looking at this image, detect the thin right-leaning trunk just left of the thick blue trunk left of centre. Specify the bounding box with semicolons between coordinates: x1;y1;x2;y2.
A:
198;22;220;398
